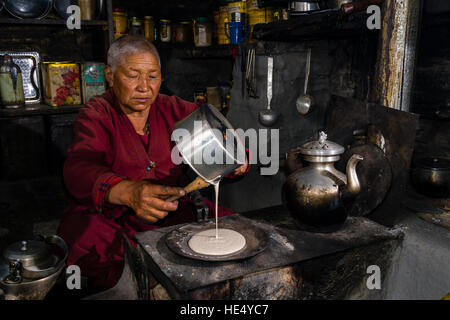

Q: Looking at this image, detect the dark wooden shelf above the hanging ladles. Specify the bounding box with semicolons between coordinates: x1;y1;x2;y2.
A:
253;10;377;41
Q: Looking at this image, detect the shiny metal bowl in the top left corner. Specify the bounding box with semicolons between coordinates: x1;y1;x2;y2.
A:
5;0;53;19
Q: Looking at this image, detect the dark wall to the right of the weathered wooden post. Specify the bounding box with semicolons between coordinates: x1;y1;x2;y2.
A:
412;0;450;160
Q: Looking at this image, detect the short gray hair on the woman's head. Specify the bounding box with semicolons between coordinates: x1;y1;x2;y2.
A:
108;35;161;72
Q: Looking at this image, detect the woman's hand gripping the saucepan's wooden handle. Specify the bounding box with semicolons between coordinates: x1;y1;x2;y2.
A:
106;180;185;223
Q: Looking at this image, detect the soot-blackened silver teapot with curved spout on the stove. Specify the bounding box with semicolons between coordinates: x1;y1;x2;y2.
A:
284;131;363;226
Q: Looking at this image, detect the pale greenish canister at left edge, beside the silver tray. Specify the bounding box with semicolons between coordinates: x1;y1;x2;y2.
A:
0;55;25;108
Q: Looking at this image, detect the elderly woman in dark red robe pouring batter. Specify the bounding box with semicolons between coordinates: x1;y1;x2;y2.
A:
58;36;248;289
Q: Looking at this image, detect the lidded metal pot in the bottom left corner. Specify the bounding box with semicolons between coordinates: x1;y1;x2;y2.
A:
0;235;67;300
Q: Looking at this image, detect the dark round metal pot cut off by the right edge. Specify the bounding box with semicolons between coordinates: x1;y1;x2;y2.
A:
411;158;450;198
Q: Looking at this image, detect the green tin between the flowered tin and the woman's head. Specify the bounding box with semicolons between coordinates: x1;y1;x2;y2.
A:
81;62;105;103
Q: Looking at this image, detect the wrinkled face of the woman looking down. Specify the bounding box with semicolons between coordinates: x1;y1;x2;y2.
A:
105;53;161;113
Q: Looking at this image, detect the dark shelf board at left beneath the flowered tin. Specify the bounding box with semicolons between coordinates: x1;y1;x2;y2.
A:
0;104;84;118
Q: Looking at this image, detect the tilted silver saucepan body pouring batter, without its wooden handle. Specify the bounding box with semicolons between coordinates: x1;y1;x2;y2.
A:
172;104;246;183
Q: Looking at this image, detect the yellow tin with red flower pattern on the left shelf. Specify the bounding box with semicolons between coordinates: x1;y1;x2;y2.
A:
42;62;81;107
